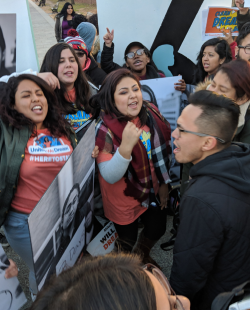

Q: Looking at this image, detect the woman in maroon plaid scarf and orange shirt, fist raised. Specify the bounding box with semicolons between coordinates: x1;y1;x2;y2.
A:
90;69;171;262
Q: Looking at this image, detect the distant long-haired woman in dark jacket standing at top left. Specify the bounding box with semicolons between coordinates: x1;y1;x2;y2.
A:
55;2;76;42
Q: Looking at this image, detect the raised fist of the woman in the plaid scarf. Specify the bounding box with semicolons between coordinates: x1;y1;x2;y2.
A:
119;122;142;159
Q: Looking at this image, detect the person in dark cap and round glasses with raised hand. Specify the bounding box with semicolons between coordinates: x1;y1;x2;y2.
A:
101;28;165;80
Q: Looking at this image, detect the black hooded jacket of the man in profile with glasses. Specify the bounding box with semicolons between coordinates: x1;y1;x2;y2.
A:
170;143;250;310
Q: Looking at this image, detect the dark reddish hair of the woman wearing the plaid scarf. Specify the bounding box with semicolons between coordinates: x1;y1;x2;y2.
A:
89;68;147;126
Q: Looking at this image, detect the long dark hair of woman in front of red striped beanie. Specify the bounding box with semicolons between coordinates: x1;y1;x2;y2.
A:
40;43;91;115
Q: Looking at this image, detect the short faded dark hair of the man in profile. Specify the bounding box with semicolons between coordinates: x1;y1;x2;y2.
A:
189;90;240;147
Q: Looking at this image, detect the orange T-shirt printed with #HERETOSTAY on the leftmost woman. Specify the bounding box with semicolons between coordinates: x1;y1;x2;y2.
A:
11;129;73;214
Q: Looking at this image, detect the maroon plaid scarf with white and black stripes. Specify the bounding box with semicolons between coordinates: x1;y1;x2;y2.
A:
96;101;171;207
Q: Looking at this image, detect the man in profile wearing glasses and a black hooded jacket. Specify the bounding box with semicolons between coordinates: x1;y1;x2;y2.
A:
170;90;250;310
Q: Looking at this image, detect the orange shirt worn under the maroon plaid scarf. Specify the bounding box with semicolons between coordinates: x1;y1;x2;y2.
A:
97;121;159;225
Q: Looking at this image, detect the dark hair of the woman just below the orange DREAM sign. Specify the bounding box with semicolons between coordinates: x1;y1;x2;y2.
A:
192;38;232;85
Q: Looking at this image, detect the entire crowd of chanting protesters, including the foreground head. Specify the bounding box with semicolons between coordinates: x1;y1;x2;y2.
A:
0;0;250;310
